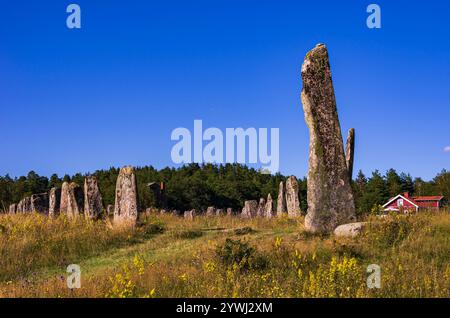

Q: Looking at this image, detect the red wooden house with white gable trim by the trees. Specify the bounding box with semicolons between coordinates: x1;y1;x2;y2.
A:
383;192;444;212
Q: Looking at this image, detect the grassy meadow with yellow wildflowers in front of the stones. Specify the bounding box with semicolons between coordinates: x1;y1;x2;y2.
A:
0;212;450;298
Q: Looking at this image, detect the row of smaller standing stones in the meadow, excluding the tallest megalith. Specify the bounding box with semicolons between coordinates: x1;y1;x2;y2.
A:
9;167;301;225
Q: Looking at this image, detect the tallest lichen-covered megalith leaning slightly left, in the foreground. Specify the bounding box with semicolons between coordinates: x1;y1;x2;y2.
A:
301;44;355;233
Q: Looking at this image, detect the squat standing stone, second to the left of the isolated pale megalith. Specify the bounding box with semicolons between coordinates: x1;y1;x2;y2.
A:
59;182;84;219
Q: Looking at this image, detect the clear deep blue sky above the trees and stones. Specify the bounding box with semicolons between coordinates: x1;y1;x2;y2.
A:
0;0;450;179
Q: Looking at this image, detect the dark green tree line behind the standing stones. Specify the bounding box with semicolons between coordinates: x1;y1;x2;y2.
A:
0;164;450;214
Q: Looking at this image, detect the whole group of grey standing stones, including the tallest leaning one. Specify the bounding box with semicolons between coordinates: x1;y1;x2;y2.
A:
6;44;363;236
